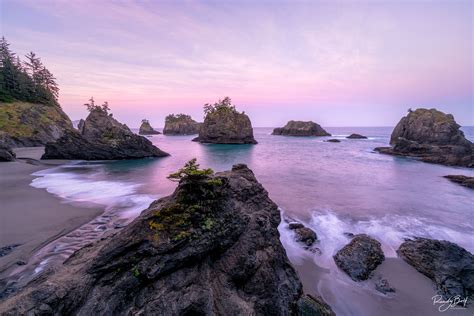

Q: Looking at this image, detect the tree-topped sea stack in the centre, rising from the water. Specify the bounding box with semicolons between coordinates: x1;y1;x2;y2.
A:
193;97;257;144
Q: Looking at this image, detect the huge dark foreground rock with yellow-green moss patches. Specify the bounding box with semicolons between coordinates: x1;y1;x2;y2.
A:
0;165;332;315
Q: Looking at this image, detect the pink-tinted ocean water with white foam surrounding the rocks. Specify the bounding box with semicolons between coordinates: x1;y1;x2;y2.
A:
13;127;474;315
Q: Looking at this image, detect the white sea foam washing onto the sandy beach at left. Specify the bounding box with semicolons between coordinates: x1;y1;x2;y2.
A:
7;164;157;282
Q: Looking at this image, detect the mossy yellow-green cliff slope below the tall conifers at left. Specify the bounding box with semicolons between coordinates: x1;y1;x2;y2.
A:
0;102;73;147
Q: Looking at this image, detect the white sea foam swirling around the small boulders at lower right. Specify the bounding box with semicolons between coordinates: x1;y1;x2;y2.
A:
279;210;474;268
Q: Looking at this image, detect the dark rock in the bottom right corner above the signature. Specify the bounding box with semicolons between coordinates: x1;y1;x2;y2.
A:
397;238;474;298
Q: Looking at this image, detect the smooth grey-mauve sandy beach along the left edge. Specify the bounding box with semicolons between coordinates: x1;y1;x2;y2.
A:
0;147;103;279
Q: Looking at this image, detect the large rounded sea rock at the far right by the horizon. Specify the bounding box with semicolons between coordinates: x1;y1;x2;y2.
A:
375;109;474;167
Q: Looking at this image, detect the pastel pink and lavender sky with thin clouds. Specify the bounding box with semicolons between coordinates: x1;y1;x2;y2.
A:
0;0;474;127
